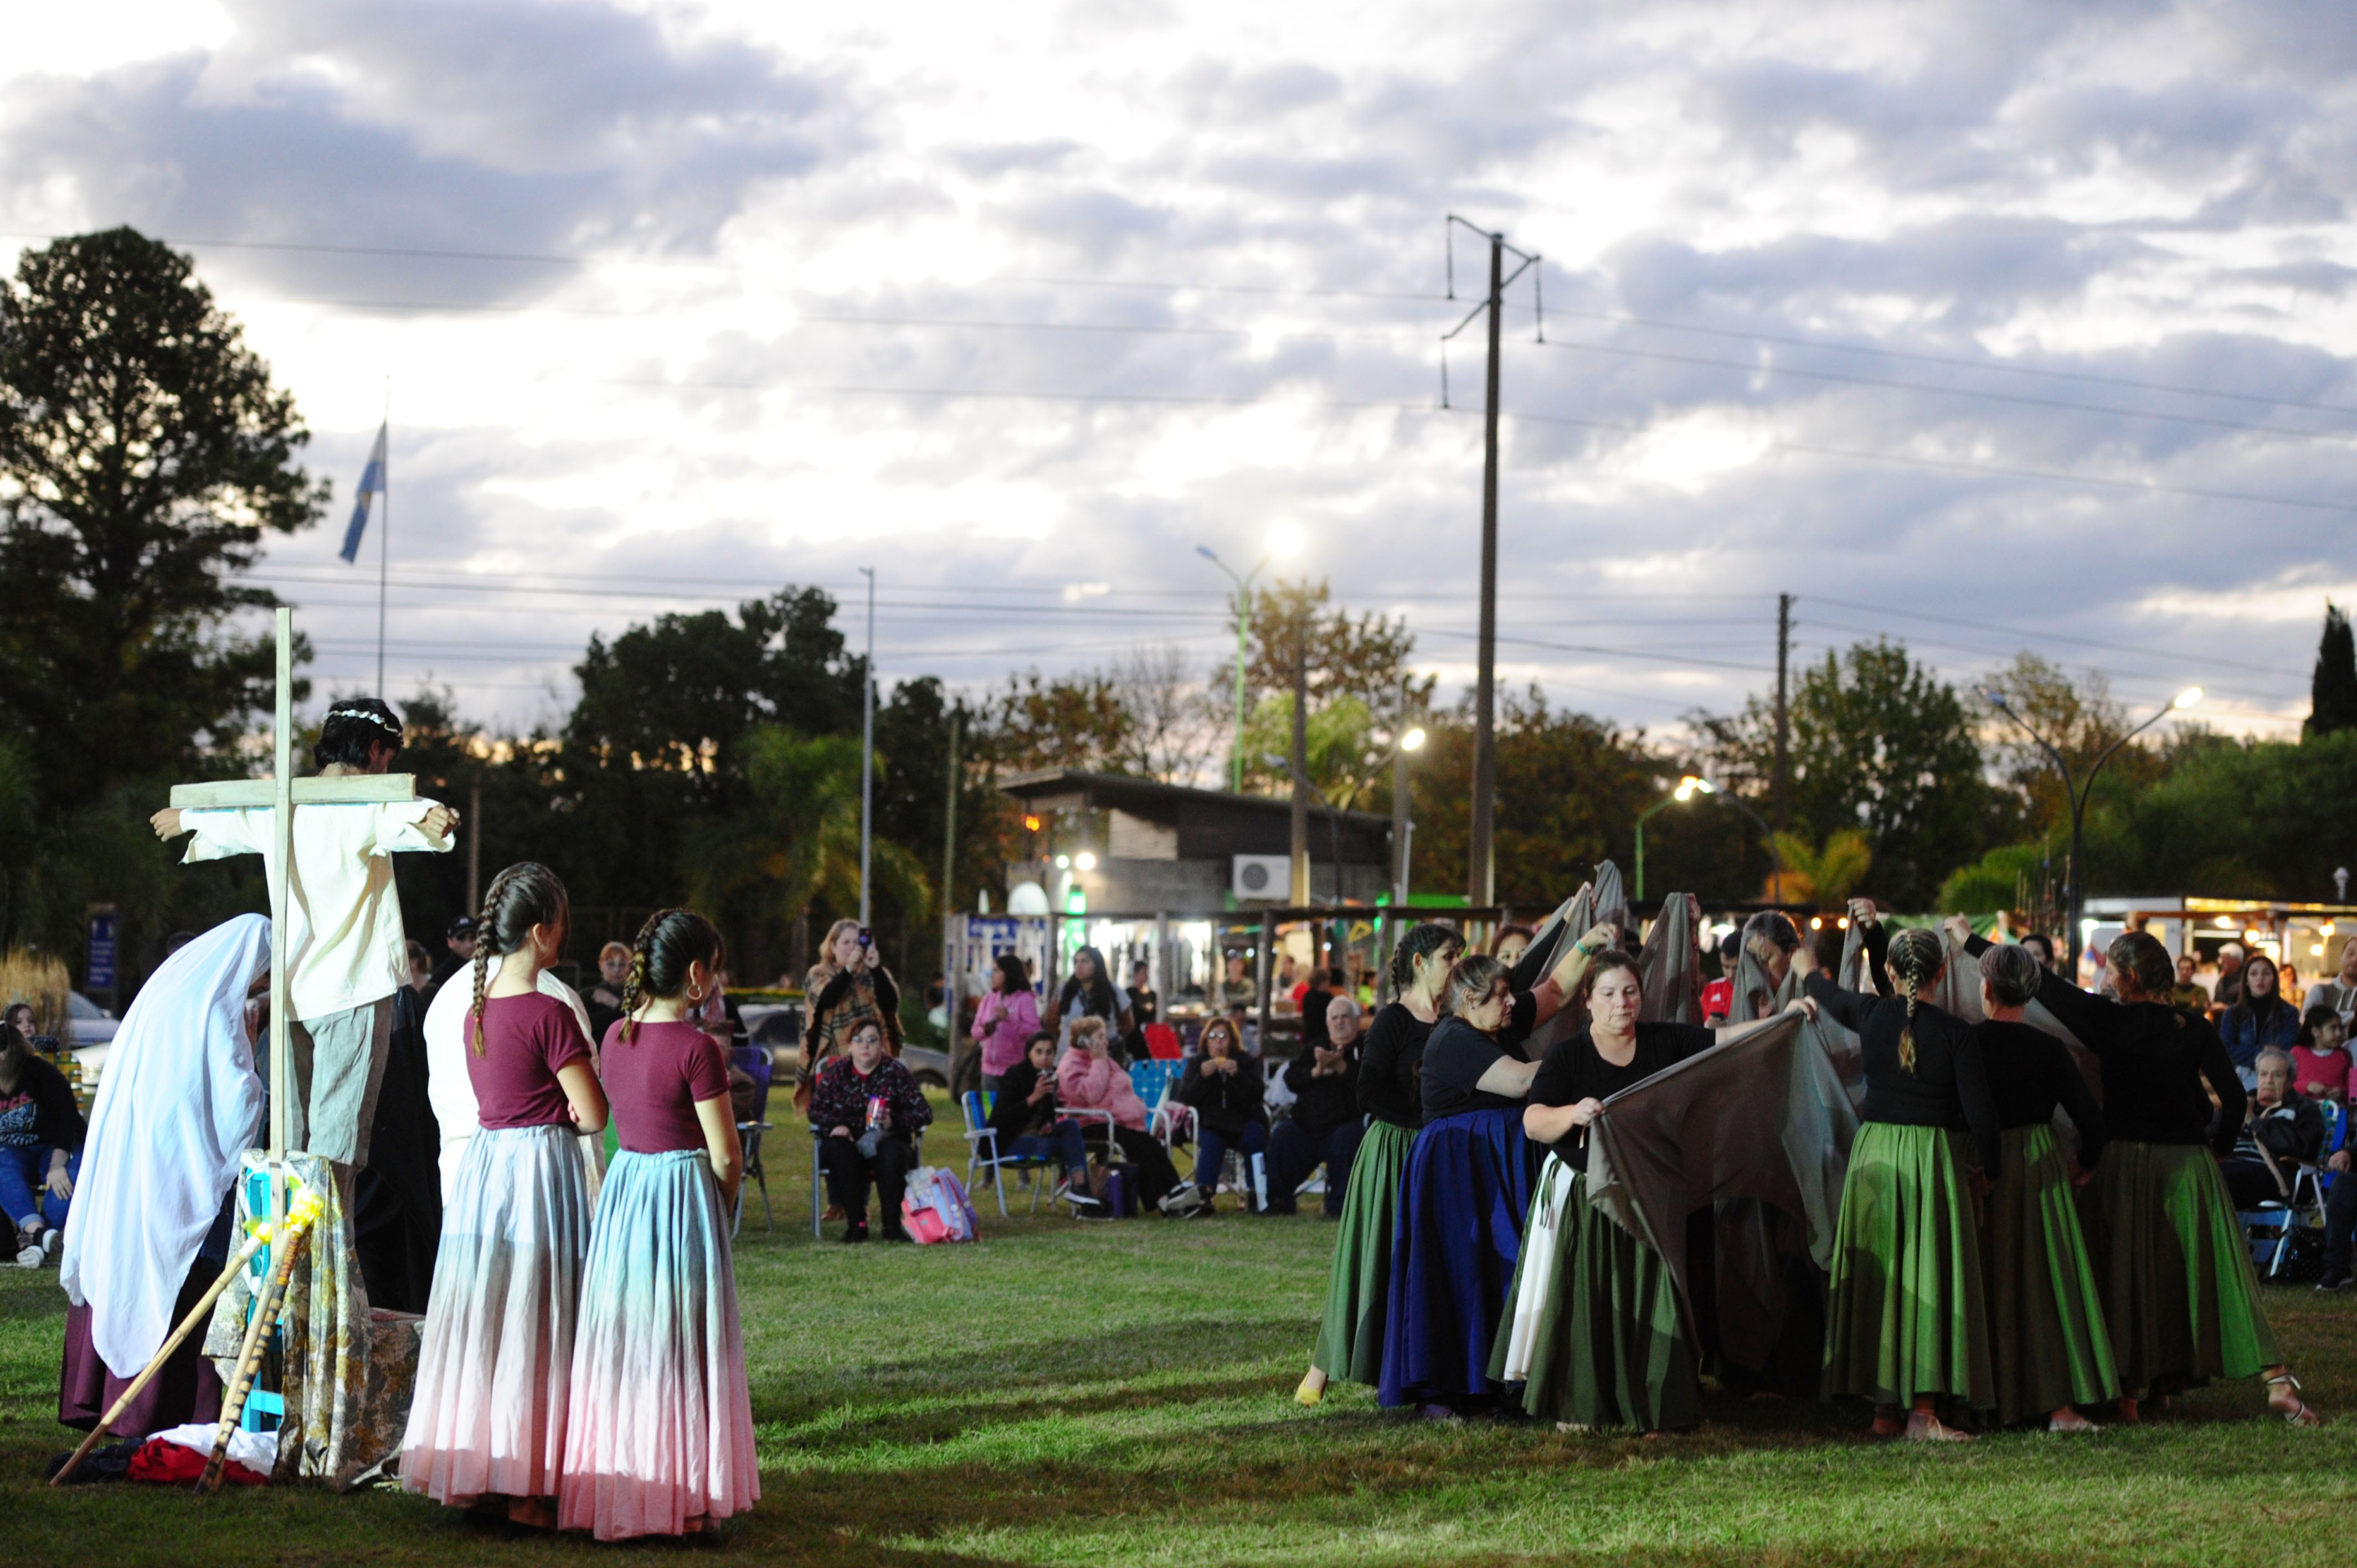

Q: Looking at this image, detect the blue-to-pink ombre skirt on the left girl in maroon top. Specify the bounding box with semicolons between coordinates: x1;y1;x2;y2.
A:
401;1127;589;1507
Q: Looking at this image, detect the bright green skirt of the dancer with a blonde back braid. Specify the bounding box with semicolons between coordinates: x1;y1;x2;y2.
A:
1824;1122;1996;1410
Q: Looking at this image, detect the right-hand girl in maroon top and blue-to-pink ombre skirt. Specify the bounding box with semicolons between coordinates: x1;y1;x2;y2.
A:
556;910;761;1540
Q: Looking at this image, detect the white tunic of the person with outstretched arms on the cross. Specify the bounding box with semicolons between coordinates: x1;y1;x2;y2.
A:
179;800;450;1021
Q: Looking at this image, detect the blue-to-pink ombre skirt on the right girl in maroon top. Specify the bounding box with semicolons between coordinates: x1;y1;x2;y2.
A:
556;1148;761;1540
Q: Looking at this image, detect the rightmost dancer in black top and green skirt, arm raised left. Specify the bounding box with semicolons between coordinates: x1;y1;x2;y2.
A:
1949;920;2319;1426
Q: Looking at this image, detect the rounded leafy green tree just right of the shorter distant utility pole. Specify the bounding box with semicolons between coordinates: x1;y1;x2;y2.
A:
1697;641;1989;908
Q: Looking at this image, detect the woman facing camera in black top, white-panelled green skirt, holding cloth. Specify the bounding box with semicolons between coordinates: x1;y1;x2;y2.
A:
1490;950;1817;1431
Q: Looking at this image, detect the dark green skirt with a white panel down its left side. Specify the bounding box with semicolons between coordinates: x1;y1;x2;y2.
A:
1490;1156;1702;1431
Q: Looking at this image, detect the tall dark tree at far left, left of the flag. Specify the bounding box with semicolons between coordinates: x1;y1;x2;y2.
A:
0;229;328;809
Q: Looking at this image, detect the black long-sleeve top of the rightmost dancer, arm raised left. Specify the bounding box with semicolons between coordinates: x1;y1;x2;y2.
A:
1966;936;2248;1156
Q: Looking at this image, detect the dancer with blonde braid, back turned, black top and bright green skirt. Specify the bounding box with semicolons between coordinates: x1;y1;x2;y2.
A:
1796;920;2004;1443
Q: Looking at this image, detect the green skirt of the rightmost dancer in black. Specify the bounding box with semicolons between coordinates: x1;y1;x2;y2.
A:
2081;1141;2282;1398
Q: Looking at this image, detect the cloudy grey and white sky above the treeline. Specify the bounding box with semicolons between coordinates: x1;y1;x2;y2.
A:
0;0;2357;750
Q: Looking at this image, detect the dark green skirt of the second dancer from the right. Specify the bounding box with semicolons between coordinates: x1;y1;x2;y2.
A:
1980;1125;2119;1424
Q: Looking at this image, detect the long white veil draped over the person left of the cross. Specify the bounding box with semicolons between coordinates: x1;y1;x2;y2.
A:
59;915;271;1377
